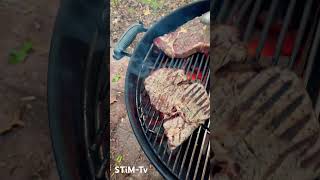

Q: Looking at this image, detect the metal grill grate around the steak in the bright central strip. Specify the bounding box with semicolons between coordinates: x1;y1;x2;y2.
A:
136;45;210;179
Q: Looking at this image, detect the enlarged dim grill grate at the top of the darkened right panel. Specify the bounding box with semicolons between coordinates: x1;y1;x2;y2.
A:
211;0;320;118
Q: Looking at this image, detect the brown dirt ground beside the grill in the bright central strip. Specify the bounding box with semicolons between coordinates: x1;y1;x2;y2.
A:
110;0;191;180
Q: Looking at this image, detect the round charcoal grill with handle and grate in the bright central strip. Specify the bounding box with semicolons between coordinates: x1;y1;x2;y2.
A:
114;1;210;179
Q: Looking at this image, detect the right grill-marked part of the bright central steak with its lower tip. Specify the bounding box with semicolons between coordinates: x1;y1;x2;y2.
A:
163;83;210;149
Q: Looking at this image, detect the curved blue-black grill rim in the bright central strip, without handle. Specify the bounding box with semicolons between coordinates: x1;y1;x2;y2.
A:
124;0;210;179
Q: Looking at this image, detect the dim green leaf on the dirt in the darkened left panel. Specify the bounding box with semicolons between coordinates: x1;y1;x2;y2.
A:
9;41;33;64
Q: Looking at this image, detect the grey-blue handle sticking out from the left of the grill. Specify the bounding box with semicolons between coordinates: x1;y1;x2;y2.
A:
113;22;147;60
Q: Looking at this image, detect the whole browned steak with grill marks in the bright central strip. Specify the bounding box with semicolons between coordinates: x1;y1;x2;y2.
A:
144;68;210;150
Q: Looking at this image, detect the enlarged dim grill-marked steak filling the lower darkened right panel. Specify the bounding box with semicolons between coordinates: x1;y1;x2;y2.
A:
210;64;320;180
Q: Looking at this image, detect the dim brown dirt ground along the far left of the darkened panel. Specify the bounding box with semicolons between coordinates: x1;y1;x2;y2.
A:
0;0;59;180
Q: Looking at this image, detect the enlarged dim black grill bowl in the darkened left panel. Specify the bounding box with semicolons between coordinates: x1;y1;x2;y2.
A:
48;0;109;180
